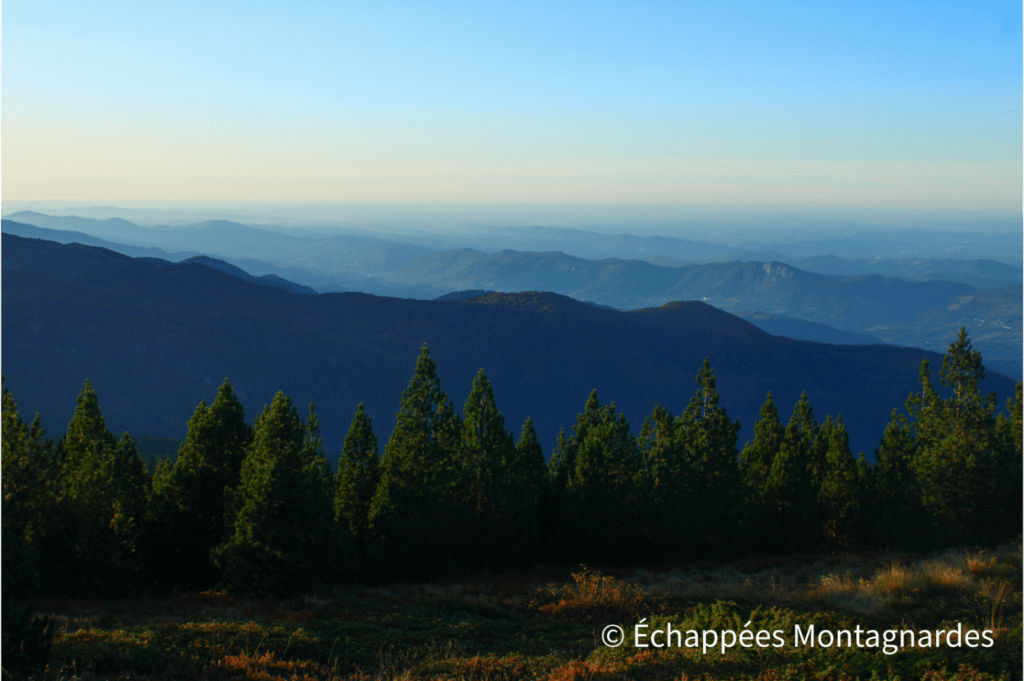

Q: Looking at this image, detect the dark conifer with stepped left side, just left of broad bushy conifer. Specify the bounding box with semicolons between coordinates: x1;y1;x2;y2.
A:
146;379;252;588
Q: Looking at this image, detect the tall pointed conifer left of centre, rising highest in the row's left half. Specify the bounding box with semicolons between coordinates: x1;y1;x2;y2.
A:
370;345;467;578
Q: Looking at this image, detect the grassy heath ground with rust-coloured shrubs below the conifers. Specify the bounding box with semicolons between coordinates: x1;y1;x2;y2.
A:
28;544;1024;681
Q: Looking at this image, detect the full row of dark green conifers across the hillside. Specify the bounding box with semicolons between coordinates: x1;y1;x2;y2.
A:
0;329;1024;659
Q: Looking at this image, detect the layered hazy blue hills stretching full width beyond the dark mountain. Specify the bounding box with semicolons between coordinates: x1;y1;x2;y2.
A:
5;213;1024;376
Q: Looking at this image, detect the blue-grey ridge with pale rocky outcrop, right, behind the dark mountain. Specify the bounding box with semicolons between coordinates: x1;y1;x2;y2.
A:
390;249;1022;365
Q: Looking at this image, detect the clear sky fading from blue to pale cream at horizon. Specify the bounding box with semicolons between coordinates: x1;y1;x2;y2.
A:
0;0;1024;213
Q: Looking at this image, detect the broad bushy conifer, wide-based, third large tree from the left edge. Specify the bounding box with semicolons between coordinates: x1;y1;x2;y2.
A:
213;392;340;595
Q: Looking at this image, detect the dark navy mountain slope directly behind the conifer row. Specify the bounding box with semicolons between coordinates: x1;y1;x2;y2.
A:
6;233;1014;454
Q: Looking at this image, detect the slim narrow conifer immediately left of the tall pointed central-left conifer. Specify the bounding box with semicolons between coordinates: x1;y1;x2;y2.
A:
334;402;380;555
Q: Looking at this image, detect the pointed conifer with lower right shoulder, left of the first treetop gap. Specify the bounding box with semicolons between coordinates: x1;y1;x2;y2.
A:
56;381;150;596
